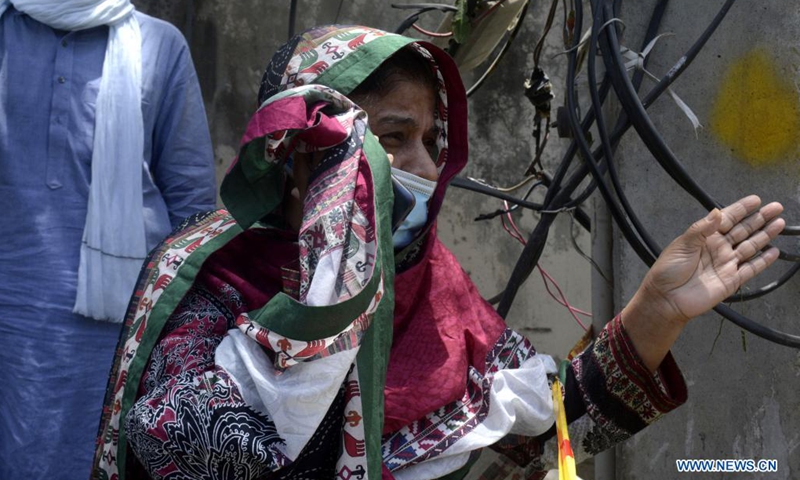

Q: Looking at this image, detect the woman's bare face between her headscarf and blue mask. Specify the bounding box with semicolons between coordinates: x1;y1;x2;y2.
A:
356;80;439;181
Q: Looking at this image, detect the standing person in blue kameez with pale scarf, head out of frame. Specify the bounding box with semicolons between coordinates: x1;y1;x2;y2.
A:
0;0;216;479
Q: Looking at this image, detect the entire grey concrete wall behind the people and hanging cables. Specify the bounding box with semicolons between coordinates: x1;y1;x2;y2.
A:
135;0;800;480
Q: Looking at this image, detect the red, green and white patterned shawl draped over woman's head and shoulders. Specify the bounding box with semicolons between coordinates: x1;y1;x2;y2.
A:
94;26;503;478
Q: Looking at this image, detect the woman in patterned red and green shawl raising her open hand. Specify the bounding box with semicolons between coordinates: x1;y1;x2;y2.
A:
93;26;783;479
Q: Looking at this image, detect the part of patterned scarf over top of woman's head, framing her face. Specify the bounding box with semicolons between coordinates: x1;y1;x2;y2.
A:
253;25;468;234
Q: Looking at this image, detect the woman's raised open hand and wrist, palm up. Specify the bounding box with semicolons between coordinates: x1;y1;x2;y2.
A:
622;195;785;371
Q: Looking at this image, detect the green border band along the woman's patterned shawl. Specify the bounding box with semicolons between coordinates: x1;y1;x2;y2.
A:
117;35;414;480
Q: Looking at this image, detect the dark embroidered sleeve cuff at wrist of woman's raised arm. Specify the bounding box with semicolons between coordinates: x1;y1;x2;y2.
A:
572;316;686;447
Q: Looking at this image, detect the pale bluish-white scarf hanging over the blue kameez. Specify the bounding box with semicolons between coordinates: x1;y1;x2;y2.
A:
0;0;147;322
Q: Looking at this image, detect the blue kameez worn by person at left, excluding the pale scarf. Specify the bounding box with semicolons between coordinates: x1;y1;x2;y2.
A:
0;7;216;480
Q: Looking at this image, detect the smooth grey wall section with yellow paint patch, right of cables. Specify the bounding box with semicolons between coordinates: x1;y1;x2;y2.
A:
615;0;800;480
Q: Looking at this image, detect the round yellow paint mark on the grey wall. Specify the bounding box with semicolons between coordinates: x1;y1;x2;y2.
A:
711;49;800;166
